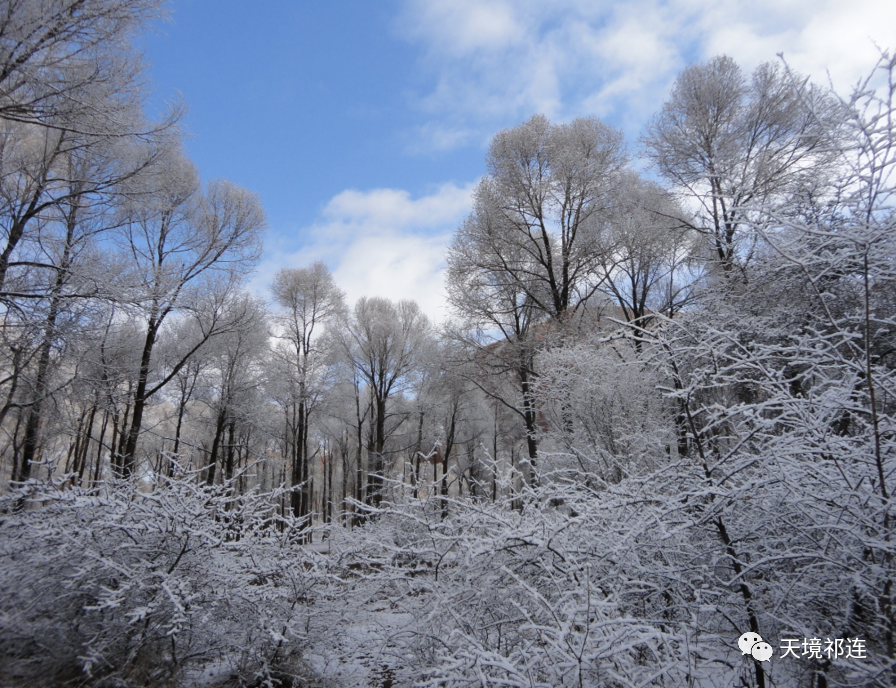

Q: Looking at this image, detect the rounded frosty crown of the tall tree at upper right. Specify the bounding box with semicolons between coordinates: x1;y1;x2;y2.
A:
644;55;833;273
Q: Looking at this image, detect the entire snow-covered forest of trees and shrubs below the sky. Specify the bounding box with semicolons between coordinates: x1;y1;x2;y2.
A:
0;0;896;688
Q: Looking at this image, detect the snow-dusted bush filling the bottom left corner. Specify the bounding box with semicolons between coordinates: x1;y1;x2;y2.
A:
0;480;328;686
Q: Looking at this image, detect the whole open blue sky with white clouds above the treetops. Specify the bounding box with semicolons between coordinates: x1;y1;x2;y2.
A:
145;0;896;320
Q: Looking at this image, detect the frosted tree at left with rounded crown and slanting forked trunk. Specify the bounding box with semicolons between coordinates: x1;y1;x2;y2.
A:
118;150;265;474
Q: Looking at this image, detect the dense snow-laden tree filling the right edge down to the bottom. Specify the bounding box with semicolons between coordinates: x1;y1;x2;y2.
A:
648;49;896;686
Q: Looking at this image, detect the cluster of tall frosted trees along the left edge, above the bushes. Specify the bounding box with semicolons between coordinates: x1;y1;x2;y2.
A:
0;0;265;481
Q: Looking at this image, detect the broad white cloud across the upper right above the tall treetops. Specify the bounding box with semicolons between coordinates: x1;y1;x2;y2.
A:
397;0;896;150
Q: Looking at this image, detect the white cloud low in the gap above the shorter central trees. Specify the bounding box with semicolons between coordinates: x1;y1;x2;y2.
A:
252;184;473;321
